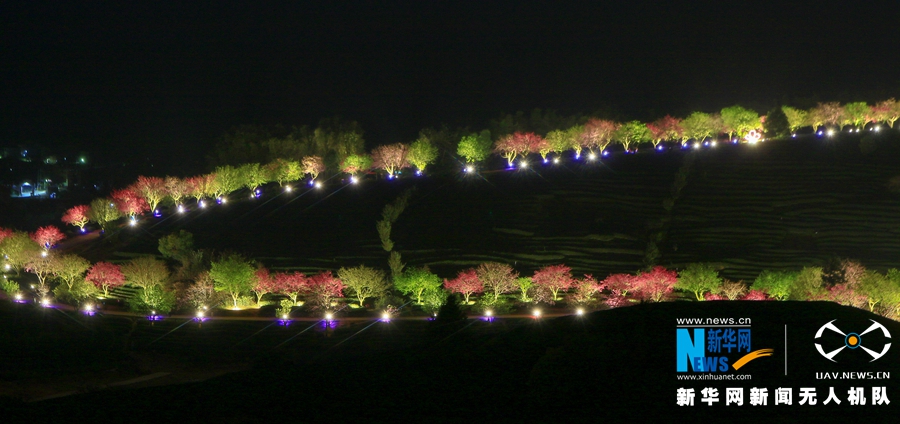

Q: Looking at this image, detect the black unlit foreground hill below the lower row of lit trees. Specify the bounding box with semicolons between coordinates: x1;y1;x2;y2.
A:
4;302;900;423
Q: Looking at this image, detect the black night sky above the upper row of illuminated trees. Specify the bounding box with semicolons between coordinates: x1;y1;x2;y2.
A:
0;0;900;171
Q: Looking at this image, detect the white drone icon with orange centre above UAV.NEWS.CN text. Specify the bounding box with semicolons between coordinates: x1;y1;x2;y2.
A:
815;319;891;362
